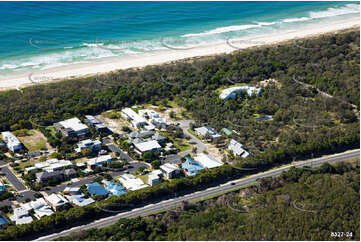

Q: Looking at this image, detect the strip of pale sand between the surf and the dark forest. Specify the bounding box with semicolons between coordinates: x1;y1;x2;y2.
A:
0;17;360;90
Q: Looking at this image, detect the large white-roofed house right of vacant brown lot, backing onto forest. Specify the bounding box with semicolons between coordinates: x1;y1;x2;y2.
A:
54;118;89;137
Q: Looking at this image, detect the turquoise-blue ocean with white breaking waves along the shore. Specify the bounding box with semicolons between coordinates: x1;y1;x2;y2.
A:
0;2;360;76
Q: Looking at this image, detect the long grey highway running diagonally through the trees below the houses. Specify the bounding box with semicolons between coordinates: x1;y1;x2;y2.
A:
37;150;360;240
